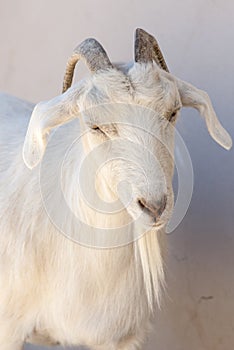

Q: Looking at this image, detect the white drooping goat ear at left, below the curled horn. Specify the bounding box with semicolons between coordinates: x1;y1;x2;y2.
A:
23;90;79;169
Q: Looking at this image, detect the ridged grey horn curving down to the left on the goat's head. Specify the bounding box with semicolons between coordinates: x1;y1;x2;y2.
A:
63;38;113;92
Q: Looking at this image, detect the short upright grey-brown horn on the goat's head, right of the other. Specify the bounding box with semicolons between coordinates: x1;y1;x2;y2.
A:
135;28;169;72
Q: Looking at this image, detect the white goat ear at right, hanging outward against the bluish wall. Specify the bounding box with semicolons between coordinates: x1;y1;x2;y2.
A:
176;79;232;149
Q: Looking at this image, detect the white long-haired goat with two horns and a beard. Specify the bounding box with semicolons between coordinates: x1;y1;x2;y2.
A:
0;29;231;350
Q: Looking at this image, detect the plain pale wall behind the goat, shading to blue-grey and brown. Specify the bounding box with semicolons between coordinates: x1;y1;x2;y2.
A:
0;0;234;350
